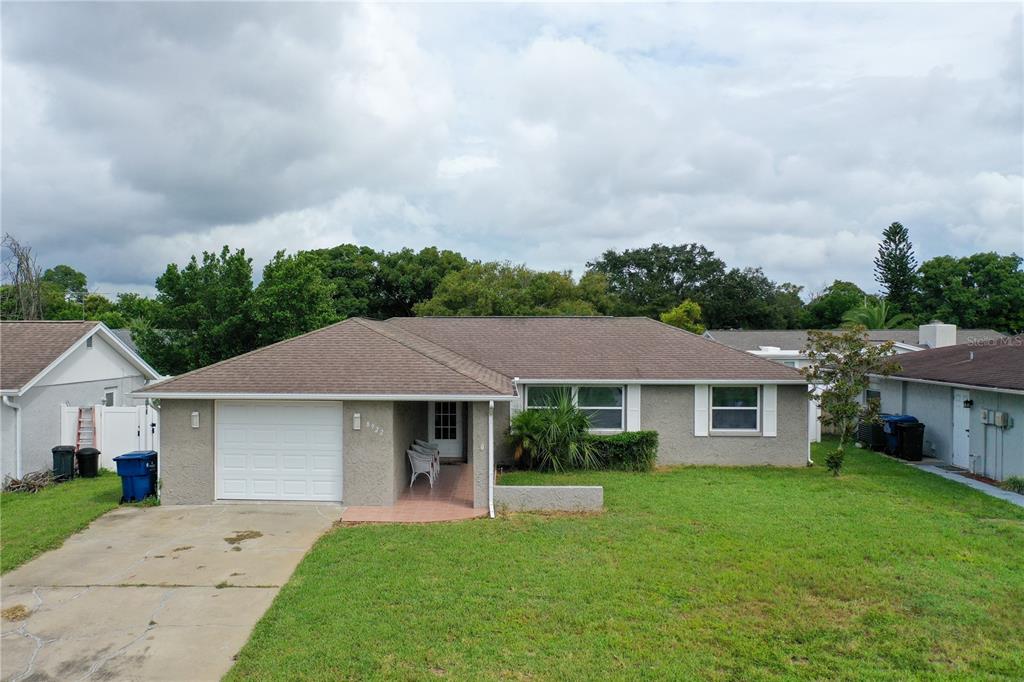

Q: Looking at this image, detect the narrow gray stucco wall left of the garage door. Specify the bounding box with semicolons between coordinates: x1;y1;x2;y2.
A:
159;398;215;505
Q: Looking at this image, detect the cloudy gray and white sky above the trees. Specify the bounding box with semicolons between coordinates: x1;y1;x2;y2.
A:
0;2;1024;292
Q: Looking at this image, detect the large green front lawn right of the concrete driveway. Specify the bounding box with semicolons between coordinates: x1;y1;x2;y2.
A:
228;440;1024;680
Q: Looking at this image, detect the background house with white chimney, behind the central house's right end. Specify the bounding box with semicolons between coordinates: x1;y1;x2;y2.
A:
705;323;1006;369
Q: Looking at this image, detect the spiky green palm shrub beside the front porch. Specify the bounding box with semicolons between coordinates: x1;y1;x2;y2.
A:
508;391;599;471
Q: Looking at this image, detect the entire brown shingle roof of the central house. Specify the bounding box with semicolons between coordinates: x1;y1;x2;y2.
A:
139;317;803;395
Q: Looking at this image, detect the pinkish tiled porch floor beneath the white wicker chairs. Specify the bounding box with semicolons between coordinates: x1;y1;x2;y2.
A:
341;464;487;523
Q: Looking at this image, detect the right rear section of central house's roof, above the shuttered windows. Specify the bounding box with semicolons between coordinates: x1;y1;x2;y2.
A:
388;317;803;381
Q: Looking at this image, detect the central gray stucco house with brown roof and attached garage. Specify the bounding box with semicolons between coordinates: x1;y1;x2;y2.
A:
136;317;808;508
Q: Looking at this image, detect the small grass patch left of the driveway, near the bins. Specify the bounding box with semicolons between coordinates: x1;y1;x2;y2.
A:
0;470;121;572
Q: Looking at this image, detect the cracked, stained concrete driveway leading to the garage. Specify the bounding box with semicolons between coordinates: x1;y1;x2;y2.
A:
0;504;343;680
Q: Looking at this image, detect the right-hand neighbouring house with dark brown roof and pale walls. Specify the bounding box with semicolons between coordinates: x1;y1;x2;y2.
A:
868;336;1024;480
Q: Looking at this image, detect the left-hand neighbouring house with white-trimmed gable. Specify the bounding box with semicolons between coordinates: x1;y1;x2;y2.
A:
0;322;161;478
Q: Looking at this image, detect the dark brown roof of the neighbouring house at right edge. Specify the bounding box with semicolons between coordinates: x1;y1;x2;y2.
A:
893;335;1024;390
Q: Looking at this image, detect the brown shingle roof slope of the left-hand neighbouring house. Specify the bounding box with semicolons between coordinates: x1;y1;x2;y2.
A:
0;322;98;391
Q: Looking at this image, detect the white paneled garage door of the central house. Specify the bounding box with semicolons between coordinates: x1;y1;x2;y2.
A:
216;400;342;502
